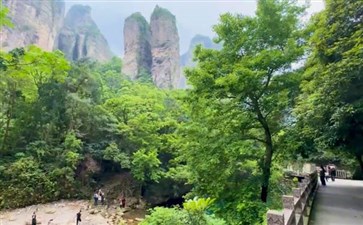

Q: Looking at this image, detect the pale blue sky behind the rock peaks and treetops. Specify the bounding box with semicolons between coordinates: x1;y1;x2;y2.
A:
65;0;324;56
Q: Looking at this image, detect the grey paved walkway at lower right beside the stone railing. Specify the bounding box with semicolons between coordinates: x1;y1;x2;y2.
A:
309;179;363;225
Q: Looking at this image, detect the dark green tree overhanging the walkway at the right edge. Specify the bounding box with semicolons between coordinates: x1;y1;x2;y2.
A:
296;0;363;174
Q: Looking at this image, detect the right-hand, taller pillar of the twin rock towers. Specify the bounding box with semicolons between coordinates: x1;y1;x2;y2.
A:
150;6;180;88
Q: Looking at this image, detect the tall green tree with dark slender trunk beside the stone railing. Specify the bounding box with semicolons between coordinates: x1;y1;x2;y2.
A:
186;0;304;202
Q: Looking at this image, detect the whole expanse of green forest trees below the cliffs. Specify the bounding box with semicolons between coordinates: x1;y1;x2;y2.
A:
0;0;363;225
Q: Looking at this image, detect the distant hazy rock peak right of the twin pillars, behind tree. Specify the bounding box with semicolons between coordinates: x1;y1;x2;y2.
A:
178;34;221;88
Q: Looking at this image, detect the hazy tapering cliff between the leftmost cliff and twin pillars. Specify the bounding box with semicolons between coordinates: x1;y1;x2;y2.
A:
58;5;113;62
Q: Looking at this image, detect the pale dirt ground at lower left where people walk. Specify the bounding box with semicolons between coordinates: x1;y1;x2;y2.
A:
0;201;145;225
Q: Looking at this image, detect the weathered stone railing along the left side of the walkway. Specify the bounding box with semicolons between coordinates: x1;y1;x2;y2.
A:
267;172;318;225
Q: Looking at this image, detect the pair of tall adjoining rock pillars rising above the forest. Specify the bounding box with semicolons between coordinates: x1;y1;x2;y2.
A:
123;6;180;89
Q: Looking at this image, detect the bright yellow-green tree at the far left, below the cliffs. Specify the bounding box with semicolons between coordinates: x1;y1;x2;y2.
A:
0;46;69;154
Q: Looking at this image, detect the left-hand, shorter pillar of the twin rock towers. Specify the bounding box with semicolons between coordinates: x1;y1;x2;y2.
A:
122;13;152;80
